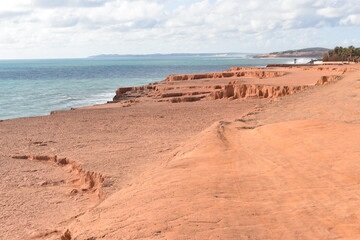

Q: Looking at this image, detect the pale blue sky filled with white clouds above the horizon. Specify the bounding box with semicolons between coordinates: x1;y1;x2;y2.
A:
0;0;360;59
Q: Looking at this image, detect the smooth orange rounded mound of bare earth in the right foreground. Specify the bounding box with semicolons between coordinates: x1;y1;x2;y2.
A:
70;120;360;239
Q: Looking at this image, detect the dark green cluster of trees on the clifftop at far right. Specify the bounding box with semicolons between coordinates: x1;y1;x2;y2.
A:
323;46;360;62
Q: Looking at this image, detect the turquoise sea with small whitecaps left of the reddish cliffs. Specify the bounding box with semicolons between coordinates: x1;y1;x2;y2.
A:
0;57;298;119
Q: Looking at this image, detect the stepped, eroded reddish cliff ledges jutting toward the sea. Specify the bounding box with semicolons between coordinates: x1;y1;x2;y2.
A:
114;67;347;103
